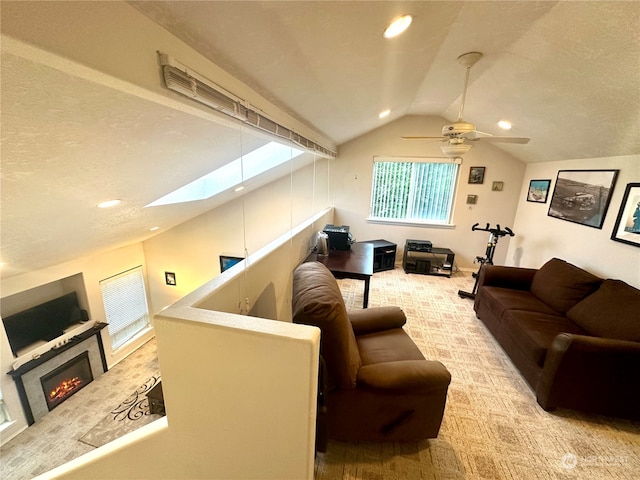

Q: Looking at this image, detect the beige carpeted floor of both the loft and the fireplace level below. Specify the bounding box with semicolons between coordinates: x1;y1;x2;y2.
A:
0;268;640;480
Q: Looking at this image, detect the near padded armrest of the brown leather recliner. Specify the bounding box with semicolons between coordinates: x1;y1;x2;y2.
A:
357;360;451;394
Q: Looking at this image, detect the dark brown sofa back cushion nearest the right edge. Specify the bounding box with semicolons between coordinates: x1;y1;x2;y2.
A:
567;279;640;342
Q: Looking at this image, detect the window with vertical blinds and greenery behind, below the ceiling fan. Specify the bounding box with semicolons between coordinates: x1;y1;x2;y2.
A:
369;157;461;225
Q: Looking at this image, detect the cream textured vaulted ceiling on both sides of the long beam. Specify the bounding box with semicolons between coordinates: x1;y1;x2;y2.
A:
1;1;640;276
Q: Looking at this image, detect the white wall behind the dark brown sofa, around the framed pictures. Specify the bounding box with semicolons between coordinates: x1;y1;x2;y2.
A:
506;155;640;288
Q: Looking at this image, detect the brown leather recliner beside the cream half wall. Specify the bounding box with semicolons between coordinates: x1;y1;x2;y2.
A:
292;262;451;441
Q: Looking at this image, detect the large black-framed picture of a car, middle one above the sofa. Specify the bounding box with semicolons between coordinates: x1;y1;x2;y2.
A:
548;170;618;228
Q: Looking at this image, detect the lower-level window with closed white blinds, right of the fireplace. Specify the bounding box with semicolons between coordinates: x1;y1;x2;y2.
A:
100;267;149;349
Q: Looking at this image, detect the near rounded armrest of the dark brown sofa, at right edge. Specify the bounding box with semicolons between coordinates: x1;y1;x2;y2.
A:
536;333;640;419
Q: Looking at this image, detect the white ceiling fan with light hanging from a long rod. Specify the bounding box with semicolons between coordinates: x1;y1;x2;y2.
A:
402;52;531;157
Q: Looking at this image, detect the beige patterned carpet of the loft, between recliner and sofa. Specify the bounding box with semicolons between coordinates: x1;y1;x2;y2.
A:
316;268;640;480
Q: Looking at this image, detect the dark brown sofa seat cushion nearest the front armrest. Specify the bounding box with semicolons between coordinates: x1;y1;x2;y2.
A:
502;310;587;367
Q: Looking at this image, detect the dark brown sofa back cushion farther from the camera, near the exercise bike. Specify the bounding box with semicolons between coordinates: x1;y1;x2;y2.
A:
531;258;602;313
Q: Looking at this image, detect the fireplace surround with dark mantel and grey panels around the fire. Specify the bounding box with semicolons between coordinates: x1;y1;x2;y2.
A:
9;324;107;425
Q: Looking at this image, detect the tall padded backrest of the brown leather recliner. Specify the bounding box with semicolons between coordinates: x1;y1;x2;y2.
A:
292;262;360;388
